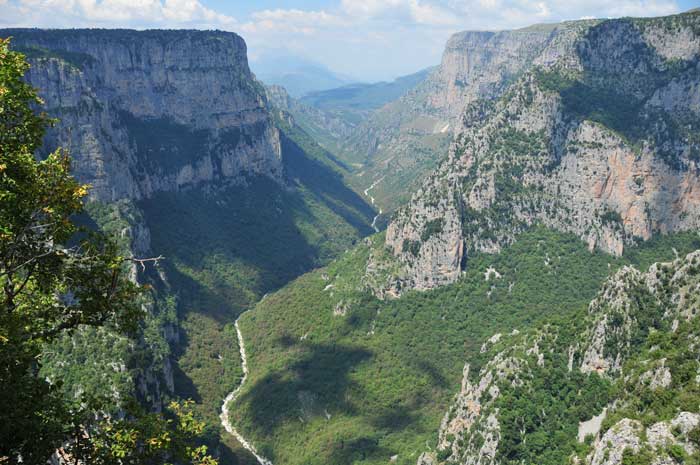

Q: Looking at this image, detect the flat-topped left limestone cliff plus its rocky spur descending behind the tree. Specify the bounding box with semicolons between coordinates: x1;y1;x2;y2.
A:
0;29;283;409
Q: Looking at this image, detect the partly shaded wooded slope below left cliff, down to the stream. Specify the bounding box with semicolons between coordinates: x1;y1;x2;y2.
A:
133;111;374;463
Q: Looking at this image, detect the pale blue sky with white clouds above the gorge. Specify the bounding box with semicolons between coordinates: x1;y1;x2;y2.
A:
0;0;700;81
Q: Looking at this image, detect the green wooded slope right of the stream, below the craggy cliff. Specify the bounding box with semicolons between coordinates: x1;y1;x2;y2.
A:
231;228;700;464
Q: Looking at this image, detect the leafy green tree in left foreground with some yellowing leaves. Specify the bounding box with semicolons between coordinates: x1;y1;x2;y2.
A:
0;39;216;464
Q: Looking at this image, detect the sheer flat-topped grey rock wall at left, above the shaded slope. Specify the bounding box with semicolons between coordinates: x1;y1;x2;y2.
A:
0;29;282;201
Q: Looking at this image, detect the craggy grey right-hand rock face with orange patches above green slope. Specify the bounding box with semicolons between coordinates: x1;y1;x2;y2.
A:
386;12;700;289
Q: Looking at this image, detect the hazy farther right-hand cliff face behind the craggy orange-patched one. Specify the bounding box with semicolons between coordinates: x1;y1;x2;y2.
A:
348;22;588;211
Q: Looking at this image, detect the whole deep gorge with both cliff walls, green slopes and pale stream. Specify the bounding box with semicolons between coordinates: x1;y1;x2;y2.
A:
0;6;700;465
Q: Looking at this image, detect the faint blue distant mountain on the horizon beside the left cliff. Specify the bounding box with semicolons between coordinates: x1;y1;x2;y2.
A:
252;53;352;98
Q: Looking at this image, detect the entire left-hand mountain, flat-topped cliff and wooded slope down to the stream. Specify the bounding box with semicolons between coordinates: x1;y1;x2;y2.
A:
0;29;374;464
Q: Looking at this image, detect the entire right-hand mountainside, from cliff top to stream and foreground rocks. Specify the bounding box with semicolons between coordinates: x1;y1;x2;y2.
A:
220;12;700;465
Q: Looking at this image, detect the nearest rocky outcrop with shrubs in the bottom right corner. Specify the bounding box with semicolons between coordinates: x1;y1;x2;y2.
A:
418;251;700;465
